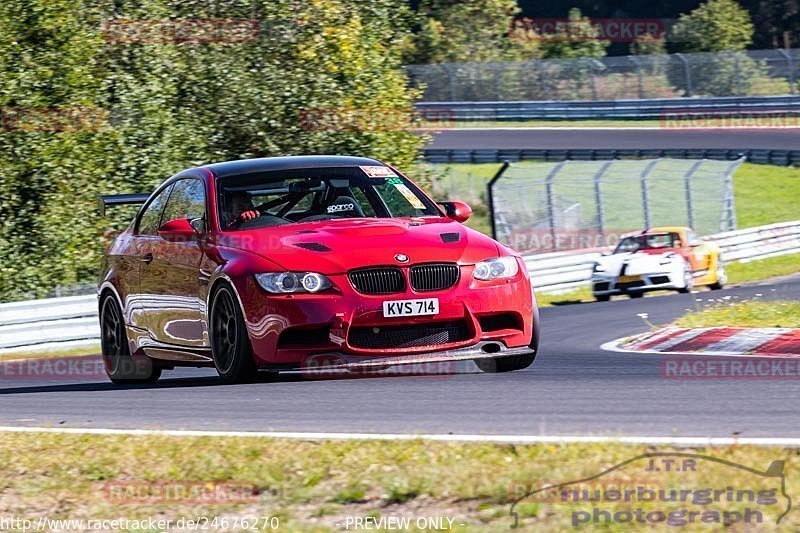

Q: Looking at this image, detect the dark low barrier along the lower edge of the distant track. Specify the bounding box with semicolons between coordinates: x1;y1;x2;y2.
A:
423;148;800;166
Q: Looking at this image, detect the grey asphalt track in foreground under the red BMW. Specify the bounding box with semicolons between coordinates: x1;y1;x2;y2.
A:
0;277;800;437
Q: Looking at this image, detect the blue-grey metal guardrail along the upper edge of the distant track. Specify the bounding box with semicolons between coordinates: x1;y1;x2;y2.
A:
416;96;800;122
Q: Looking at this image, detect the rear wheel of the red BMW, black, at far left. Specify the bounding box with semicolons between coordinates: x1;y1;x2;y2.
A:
100;294;161;384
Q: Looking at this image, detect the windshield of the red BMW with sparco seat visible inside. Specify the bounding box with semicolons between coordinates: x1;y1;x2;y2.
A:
217;166;441;230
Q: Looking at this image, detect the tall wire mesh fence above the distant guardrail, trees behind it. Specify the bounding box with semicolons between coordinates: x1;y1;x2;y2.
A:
406;48;800;102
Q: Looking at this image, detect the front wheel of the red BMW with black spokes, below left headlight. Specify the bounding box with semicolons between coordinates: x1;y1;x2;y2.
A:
210;285;258;383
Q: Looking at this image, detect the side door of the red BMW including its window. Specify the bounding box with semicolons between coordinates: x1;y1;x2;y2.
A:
140;177;208;348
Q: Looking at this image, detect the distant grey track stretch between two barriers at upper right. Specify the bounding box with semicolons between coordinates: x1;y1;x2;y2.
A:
427;127;800;150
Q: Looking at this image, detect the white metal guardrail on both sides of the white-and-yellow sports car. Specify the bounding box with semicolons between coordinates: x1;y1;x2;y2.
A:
525;220;800;292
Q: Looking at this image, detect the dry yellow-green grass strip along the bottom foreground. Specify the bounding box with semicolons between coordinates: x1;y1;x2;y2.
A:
0;433;800;531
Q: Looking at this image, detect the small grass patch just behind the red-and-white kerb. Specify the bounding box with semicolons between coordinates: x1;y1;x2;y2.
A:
675;300;800;328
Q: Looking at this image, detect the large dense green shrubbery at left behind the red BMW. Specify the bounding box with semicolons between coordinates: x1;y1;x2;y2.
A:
0;0;423;300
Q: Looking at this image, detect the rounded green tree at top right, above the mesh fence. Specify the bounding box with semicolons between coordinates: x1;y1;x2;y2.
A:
673;0;754;52
